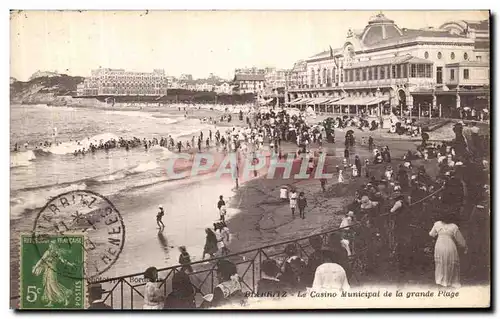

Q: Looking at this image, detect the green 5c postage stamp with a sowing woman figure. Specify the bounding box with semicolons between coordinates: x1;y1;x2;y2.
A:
19;235;85;310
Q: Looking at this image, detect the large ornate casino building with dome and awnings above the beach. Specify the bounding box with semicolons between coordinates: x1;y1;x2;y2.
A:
286;13;490;116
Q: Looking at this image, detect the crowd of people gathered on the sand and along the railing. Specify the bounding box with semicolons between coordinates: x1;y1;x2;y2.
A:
85;105;489;309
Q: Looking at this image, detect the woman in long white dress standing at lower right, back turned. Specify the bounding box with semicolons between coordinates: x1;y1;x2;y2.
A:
429;216;467;288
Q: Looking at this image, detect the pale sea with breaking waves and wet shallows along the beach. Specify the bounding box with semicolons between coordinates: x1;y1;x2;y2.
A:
10;105;236;277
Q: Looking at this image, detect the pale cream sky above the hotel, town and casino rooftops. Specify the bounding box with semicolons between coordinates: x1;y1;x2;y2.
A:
10;11;488;81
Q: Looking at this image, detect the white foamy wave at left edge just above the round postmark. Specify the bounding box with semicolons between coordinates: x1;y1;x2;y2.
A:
10;182;87;218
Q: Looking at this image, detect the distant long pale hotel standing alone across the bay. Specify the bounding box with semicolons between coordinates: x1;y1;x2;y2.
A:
77;68;168;96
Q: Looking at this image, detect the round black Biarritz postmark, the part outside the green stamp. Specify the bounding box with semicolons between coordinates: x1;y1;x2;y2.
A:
32;190;125;280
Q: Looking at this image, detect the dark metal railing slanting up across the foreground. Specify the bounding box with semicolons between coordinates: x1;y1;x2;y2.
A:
86;189;442;309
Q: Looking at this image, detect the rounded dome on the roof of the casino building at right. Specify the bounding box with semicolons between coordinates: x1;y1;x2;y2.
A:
361;13;403;46
